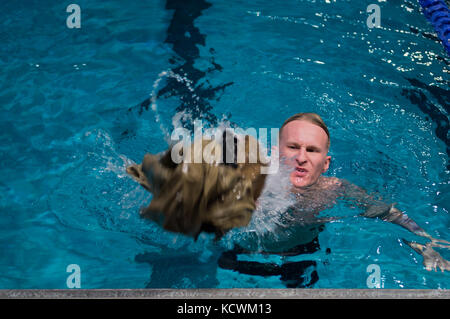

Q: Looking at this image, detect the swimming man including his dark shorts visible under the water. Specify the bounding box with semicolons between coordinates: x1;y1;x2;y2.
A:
219;113;450;286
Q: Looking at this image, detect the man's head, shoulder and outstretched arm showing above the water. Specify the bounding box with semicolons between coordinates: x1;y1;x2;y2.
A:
280;113;450;264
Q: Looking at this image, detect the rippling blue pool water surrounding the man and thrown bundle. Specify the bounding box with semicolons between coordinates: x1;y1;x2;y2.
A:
0;0;450;289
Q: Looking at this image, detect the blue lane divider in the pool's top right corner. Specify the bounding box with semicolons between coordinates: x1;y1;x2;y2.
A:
419;0;450;56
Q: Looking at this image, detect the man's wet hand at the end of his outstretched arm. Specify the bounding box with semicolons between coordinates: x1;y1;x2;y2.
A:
403;238;450;272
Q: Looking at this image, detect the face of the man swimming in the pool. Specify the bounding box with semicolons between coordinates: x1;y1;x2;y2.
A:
280;120;331;189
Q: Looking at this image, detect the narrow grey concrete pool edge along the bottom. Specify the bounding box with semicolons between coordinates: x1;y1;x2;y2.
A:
0;289;450;299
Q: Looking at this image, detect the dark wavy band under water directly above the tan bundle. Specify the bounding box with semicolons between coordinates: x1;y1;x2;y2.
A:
129;0;233;129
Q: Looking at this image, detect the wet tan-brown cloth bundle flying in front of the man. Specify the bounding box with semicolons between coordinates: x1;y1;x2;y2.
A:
127;132;266;239
